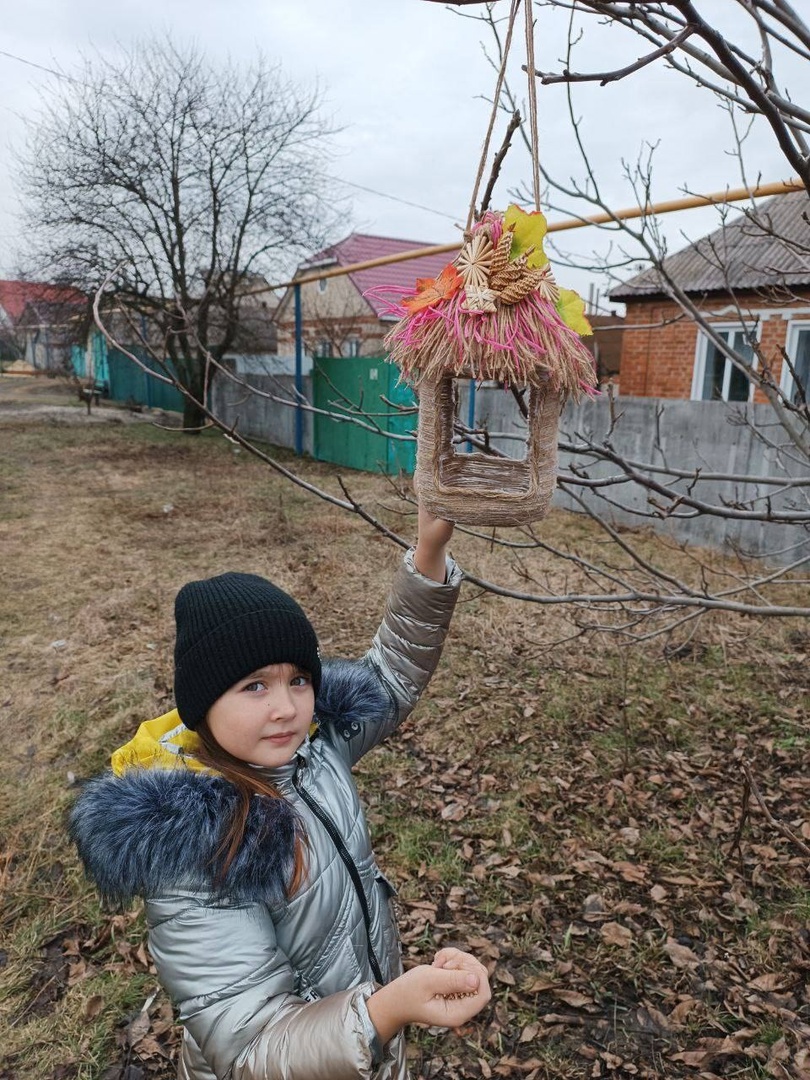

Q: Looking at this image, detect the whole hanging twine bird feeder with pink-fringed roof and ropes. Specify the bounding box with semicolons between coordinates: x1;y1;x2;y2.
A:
386;0;595;525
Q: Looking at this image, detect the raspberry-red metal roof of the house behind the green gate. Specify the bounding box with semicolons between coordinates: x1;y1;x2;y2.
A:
301;232;461;316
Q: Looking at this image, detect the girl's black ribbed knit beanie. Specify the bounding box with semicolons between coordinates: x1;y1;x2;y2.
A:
174;573;321;731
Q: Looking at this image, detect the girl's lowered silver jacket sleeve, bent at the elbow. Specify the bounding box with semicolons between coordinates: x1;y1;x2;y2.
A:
147;894;376;1080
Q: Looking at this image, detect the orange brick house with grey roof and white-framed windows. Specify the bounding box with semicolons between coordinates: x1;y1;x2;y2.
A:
610;191;810;401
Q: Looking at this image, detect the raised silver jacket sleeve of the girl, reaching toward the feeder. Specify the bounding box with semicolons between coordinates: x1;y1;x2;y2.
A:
346;549;462;765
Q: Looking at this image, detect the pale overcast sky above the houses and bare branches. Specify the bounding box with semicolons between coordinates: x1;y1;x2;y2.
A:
0;0;798;306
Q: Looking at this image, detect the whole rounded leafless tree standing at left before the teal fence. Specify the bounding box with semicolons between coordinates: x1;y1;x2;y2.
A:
22;40;334;430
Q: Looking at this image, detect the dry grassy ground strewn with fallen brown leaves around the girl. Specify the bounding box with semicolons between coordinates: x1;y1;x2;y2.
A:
0;379;810;1080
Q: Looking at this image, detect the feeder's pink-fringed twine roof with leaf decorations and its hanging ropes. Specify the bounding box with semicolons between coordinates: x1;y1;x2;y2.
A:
384;0;594;400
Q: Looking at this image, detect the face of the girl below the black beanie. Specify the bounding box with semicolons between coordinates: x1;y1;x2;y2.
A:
207;664;315;769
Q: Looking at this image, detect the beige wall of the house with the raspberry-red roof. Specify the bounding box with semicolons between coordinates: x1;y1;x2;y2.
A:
276;275;389;356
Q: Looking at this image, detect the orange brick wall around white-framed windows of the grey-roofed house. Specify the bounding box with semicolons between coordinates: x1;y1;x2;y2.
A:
621;289;810;402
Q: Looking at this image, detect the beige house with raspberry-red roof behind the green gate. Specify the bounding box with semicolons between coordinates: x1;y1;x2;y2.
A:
275;232;453;356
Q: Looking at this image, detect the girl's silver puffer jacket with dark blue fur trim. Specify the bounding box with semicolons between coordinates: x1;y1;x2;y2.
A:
71;552;461;1080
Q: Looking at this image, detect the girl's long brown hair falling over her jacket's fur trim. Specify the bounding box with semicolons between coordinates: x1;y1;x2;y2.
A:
197;720;307;897
